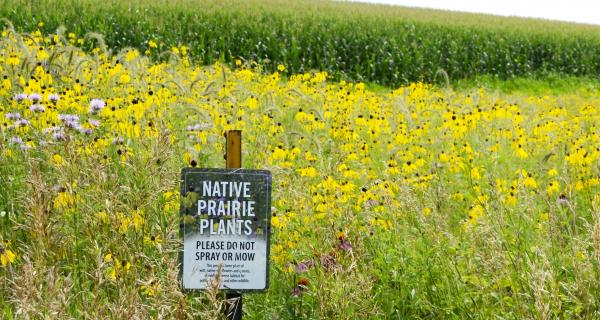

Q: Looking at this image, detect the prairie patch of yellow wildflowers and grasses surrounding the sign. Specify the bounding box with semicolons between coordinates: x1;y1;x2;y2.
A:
0;29;600;319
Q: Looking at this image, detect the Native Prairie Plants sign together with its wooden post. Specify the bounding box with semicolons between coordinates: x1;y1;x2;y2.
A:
181;130;271;319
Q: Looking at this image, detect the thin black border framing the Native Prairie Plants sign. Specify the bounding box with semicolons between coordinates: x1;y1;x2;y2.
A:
178;167;273;293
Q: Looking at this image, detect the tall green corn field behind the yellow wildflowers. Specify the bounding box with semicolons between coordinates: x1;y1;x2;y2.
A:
0;0;600;86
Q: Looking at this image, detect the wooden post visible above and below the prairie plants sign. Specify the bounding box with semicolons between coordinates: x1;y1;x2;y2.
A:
225;130;242;320
